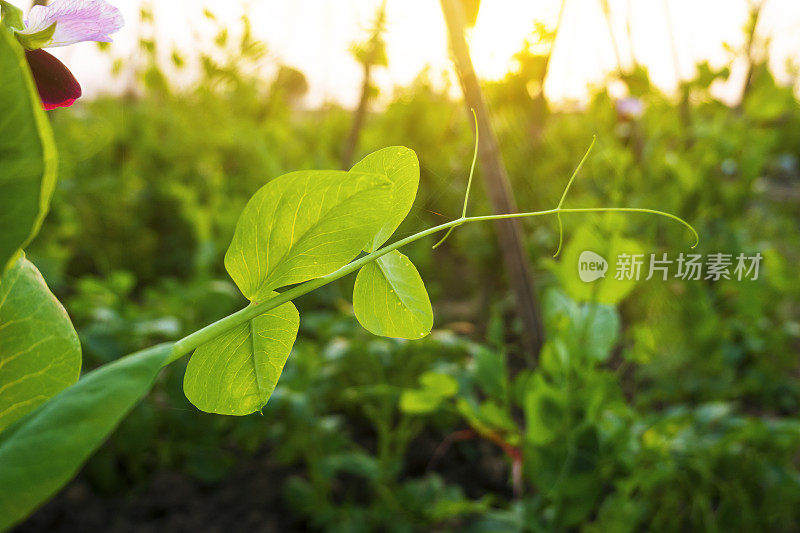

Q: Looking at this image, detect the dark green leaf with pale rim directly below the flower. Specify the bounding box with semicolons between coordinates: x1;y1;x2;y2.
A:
0;23;56;272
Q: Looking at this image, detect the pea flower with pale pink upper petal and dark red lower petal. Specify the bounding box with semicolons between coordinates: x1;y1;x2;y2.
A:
0;0;124;110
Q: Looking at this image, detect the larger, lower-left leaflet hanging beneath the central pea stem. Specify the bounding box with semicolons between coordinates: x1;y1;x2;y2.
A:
183;293;300;416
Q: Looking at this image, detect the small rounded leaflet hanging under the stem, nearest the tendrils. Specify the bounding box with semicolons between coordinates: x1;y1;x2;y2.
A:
353;250;433;339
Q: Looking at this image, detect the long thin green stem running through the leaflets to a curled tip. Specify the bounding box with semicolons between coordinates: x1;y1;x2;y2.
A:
166;207;700;364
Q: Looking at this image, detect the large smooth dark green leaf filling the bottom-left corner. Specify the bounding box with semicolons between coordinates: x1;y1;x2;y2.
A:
0;344;172;530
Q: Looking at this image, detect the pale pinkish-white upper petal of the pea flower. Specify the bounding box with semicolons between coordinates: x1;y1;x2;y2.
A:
19;0;124;48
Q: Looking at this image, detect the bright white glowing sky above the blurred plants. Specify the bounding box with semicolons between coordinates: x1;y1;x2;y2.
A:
48;0;800;107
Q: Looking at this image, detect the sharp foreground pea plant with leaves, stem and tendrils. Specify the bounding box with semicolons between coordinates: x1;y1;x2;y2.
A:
0;0;698;530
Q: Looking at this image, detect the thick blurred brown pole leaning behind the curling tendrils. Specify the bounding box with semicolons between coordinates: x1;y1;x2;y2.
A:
441;0;544;363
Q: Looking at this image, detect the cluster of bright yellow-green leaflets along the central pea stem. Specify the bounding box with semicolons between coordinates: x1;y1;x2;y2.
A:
184;147;433;415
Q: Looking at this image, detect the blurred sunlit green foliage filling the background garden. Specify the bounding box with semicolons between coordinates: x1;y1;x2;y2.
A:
18;10;800;531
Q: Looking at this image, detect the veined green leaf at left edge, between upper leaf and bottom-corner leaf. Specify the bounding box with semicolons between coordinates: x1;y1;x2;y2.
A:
0;255;81;431
